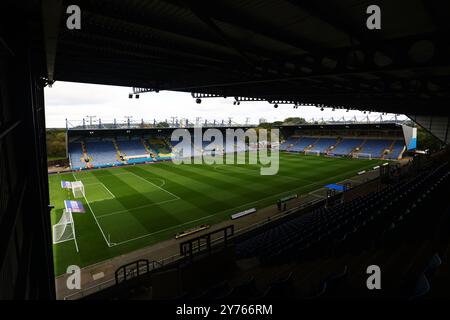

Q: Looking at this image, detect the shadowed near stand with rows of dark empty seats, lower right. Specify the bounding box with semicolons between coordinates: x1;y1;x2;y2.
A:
230;163;450;299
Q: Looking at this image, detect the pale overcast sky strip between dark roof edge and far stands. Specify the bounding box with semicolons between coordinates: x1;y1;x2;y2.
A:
45;82;406;128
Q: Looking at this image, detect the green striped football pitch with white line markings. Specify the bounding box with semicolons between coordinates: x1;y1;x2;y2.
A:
49;153;386;275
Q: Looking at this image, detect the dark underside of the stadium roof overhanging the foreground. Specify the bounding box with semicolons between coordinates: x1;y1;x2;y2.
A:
39;0;450;115
